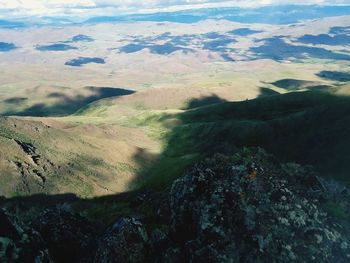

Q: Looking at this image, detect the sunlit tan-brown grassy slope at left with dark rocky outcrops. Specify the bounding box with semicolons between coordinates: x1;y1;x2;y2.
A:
0;118;157;196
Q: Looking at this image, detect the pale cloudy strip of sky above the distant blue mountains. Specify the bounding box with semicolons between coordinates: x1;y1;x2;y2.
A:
0;0;350;19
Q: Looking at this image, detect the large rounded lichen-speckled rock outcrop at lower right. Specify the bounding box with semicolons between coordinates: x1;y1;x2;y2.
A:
170;149;350;262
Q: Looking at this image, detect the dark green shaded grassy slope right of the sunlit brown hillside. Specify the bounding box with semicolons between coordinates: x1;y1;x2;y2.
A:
134;86;350;191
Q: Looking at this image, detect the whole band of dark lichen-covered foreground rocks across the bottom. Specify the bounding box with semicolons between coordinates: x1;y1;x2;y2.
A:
0;148;350;263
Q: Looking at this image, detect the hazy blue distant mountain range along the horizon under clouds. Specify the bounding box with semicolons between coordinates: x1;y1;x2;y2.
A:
0;5;350;28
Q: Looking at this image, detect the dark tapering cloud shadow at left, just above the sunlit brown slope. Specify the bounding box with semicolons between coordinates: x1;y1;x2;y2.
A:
3;86;135;117
